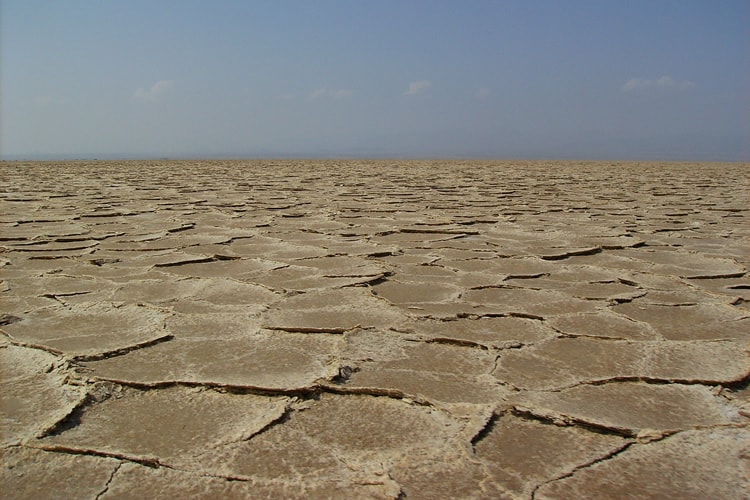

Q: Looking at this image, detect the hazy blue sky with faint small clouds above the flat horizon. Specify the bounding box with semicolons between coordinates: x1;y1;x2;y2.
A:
0;0;750;161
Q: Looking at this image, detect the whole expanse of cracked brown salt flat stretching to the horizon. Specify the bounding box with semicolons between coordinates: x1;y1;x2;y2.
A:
0;161;750;499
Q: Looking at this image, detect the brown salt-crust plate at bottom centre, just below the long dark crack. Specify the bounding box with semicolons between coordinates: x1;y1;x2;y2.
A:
214;394;461;477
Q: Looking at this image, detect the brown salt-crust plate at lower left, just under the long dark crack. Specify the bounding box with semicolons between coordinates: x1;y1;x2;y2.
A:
41;387;288;470
